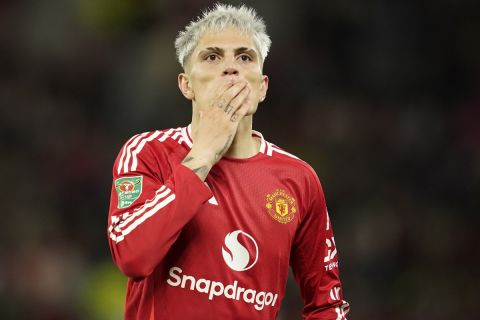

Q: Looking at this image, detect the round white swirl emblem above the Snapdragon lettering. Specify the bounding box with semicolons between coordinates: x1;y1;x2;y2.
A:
222;230;258;271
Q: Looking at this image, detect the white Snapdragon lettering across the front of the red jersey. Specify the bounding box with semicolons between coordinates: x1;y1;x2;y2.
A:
167;267;278;311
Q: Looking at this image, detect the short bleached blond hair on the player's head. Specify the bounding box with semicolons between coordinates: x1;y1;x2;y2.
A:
175;3;272;68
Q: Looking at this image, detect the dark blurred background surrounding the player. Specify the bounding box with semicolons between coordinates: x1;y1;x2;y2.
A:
0;0;480;320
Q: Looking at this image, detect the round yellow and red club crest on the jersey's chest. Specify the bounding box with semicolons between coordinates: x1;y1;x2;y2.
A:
265;189;297;224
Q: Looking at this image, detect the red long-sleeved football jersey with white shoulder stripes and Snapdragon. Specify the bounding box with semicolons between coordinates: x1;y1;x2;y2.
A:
108;126;349;320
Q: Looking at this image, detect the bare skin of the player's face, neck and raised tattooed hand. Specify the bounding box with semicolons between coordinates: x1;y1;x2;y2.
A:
178;28;268;180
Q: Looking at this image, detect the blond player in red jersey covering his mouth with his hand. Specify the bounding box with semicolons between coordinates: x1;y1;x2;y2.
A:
108;5;349;320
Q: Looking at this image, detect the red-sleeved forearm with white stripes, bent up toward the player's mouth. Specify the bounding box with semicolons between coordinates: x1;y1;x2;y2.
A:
108;166;211;278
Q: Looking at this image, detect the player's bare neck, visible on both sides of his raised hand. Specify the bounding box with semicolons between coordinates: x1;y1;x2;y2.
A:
192;115;260;159
